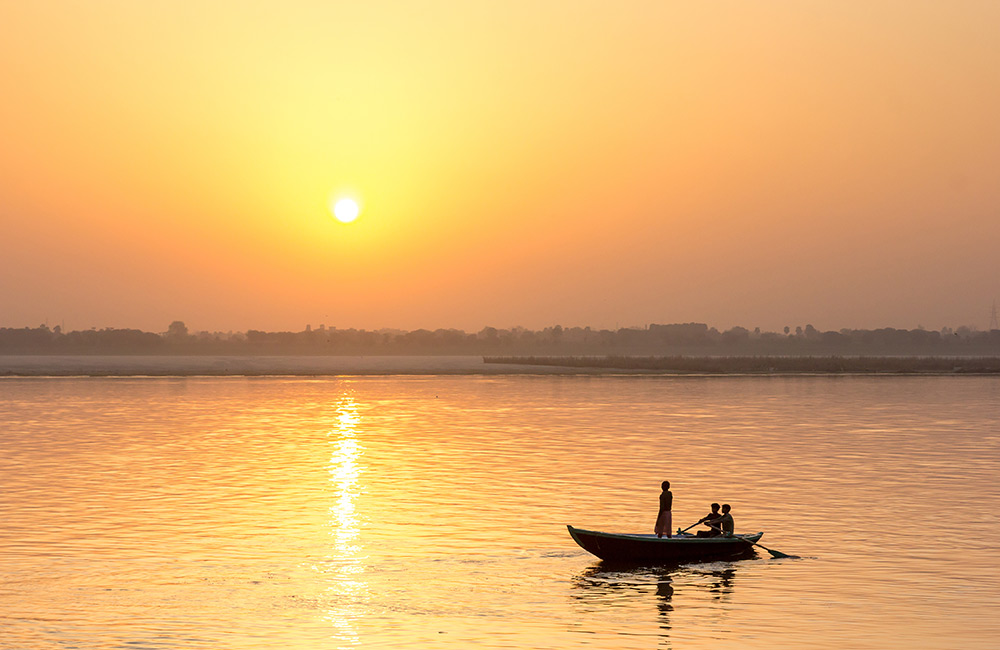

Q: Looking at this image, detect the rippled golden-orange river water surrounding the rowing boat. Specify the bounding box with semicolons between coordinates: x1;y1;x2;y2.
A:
0;376;1000;649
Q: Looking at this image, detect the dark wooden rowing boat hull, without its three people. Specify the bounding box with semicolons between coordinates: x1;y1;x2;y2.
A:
566;526;764;564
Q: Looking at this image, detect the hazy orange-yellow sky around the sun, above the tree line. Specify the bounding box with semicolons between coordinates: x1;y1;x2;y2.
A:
0;0;1000;331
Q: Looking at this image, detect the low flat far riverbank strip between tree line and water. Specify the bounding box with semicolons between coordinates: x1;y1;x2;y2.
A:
0;355;1000;379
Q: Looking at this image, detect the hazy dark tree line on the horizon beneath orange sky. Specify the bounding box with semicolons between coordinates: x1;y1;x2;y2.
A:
0;321;1000;356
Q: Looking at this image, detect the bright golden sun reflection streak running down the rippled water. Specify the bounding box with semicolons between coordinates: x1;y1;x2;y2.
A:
324;396;368;646
